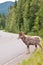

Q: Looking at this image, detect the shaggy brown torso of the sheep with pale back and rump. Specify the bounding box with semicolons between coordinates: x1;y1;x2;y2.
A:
26;36;41;45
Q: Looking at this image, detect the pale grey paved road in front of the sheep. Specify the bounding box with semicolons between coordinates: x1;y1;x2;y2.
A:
0;30;35;65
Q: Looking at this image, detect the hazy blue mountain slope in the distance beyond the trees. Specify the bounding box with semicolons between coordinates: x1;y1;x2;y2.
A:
0;1;14;14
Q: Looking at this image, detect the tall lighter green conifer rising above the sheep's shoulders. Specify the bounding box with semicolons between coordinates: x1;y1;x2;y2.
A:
23;0;31;33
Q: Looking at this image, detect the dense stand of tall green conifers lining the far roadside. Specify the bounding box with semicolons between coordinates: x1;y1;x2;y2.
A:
0;0;43;37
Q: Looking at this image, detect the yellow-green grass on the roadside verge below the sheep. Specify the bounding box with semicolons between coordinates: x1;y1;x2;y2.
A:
19;39;43;65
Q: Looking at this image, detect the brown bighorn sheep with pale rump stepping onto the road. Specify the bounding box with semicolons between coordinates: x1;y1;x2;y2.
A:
19;32;42;53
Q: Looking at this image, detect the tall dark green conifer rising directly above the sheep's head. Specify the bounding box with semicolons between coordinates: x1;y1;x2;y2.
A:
17;0;26;31
